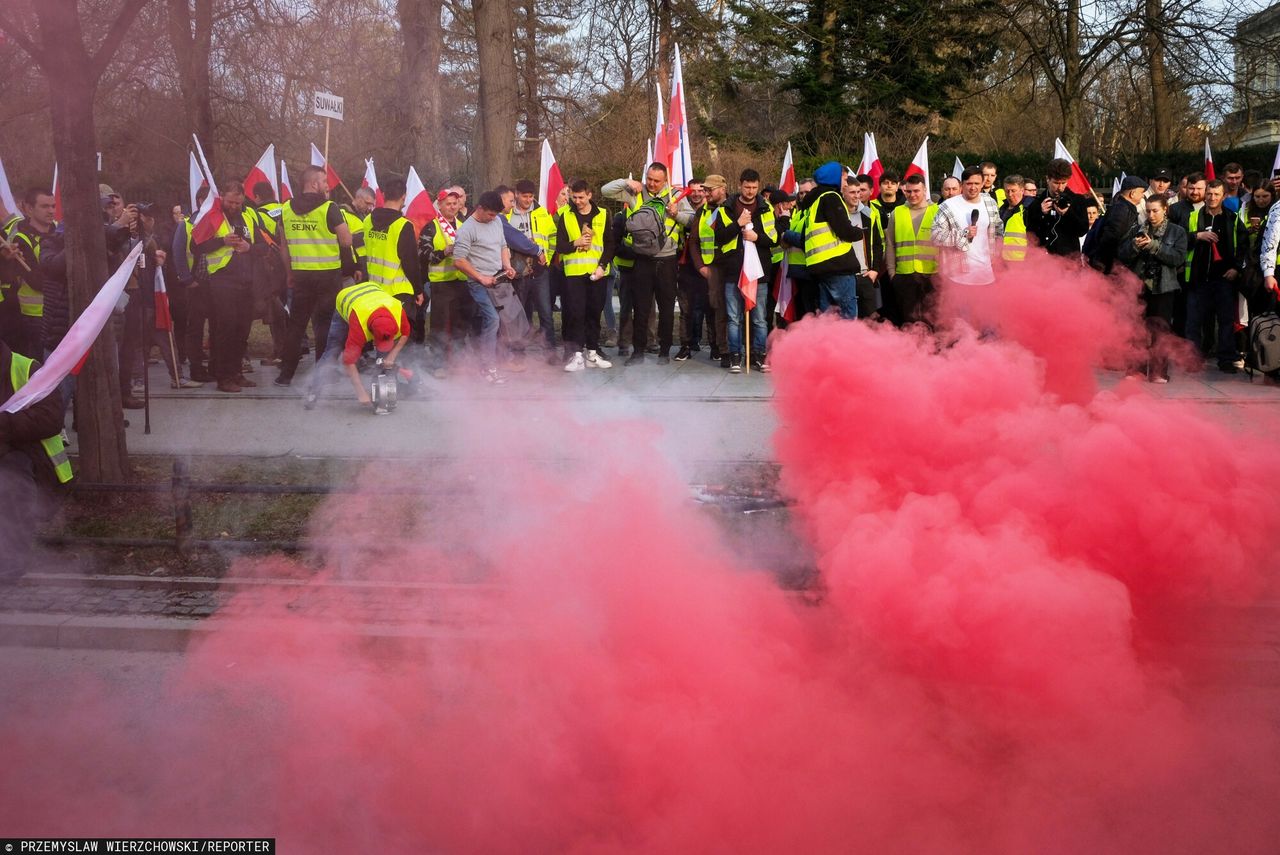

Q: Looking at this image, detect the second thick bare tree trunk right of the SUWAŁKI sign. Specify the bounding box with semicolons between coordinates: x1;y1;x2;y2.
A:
472;0;516;189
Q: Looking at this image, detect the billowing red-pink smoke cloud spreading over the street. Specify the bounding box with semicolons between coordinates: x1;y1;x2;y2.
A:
0;257;1280;854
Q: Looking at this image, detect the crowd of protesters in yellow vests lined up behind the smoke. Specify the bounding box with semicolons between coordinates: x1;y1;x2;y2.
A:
0;151;1280;425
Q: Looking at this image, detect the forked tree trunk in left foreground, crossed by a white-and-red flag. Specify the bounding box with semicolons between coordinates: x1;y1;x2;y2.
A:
19;0;146;481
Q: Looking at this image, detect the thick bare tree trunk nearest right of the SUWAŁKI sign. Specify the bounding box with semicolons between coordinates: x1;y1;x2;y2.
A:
396;0;449;183
